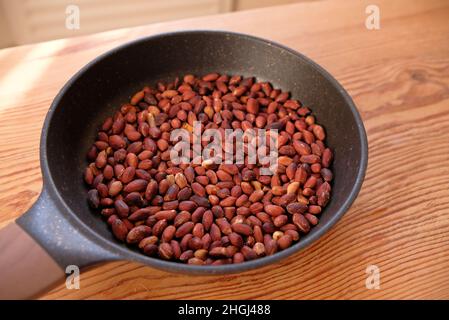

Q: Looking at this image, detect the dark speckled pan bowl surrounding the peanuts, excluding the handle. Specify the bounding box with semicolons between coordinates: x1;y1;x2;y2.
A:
41;31;367;273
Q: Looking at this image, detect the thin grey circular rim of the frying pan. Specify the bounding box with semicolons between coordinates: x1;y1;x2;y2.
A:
40;30;368;274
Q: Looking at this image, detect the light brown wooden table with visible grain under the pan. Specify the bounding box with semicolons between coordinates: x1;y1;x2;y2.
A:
0;0;449;299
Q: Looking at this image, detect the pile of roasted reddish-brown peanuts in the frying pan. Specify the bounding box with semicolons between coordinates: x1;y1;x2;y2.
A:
84;73;333;265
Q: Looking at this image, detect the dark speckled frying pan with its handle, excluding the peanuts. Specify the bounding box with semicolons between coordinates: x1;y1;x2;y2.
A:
0;31;368;298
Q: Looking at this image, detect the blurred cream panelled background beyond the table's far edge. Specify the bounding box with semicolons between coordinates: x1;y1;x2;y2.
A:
0;0;312;48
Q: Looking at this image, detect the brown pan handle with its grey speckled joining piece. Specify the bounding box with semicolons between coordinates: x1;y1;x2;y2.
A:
0;188;119;299
